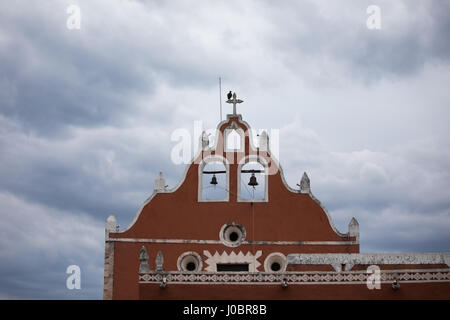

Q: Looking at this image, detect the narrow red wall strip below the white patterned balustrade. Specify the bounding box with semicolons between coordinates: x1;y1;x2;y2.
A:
139;283;450;300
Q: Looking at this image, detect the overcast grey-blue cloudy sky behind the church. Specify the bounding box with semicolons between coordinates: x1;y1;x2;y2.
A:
0;0;450;299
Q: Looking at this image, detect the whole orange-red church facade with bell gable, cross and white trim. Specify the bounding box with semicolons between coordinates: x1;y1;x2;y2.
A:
104;95;450;300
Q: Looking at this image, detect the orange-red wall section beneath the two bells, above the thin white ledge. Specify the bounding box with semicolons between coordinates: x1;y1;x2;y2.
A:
111;172;355;241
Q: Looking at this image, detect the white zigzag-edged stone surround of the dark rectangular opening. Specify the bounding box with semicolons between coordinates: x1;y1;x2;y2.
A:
203;250;262;272
